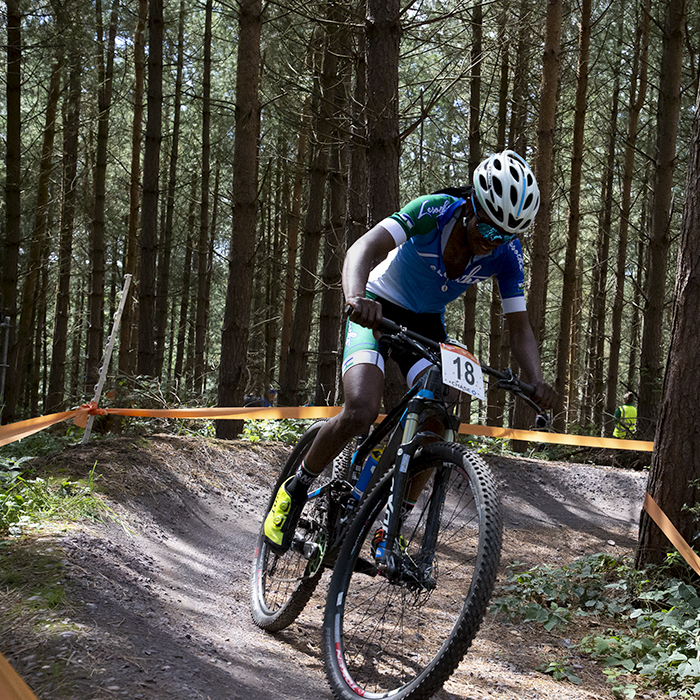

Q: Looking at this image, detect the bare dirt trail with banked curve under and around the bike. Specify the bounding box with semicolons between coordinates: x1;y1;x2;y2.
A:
0;435;662;700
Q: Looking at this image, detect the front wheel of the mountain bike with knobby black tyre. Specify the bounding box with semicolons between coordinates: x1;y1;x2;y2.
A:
323;443;502;700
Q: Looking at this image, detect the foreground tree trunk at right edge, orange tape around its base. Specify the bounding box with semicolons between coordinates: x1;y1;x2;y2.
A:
635;76;700;568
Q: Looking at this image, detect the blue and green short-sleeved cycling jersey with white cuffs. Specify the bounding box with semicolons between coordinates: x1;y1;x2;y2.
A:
367;194;525;313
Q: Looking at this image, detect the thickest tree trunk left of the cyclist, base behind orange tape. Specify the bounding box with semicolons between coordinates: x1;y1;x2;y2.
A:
216;0;262;439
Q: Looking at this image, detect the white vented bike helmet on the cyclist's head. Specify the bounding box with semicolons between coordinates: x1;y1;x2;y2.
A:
474;151;540;233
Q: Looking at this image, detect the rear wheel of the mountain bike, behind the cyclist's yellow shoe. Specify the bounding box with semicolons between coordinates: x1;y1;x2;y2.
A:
250;423;328;632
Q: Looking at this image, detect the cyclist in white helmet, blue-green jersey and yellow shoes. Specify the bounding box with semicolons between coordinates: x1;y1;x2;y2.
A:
264;150;556;552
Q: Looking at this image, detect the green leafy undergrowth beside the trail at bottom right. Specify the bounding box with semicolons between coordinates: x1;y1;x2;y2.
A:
492;554;700;698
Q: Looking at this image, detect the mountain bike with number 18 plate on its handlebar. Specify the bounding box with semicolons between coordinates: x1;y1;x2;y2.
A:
250;319;539;700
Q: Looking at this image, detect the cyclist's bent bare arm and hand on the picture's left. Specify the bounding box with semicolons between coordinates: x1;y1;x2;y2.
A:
343;224;396;328
